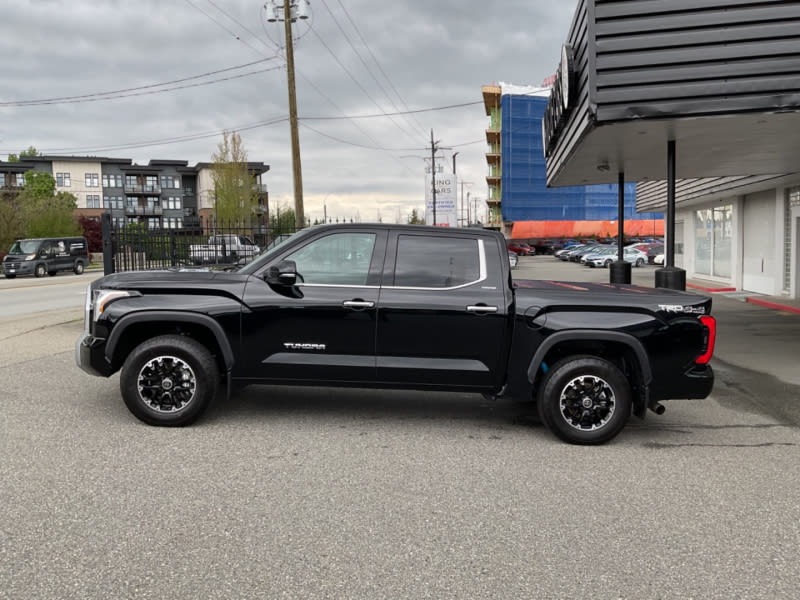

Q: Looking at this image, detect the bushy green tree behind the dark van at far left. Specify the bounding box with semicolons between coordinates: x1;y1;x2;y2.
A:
17;171;81;237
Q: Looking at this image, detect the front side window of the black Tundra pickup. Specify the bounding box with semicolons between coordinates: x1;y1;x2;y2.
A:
286;233;375;285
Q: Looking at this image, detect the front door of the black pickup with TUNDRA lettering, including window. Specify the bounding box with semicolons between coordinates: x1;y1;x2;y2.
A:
236;229;386;383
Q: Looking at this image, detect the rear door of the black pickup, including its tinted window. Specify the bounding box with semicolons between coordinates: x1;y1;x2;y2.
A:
377;230;510;390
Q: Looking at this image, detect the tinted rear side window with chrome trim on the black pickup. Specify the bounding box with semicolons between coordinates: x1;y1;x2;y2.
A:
394;235;481;288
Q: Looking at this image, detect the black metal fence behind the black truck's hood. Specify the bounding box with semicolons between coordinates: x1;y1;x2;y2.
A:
102;214;294;275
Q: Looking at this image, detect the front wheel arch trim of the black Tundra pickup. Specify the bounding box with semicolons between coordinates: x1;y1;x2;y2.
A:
105;311;234;373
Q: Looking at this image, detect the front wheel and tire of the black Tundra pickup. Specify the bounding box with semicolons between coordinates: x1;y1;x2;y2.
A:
119;335;219;427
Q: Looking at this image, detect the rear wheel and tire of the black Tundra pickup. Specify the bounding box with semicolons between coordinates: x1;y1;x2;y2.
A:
537;355;631;445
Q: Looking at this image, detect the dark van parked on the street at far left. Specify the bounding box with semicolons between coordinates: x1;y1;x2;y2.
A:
3;237;89;279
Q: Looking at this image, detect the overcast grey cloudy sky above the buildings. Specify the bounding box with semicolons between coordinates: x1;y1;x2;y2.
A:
0;0;575;221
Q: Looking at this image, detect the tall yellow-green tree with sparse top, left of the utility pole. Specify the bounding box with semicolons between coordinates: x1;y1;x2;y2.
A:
211;131;258;223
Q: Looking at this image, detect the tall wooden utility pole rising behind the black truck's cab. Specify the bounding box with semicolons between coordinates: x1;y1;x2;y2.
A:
264;0;308;231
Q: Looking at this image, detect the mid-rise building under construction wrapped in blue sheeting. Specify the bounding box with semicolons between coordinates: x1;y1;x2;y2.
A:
483;83;663;235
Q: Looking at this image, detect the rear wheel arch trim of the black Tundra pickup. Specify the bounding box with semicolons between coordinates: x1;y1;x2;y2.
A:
528;329;653;417
